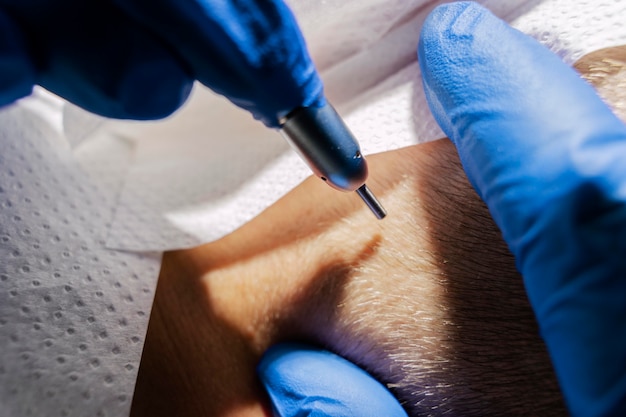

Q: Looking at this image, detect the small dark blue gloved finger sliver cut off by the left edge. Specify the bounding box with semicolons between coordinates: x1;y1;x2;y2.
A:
0;10;35;107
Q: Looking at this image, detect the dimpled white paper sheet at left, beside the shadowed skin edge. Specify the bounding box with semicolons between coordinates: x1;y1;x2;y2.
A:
0;98;159;417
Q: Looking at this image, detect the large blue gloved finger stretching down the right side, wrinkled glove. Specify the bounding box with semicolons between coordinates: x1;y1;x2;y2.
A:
418;2;626;416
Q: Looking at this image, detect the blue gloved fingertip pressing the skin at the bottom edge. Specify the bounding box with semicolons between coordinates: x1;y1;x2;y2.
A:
257;343;406;417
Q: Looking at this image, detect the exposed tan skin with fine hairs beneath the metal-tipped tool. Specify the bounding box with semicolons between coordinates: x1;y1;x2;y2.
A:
131;48;626;417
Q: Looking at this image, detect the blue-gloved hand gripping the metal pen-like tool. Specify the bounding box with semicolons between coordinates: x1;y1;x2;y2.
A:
0;0;324;127
